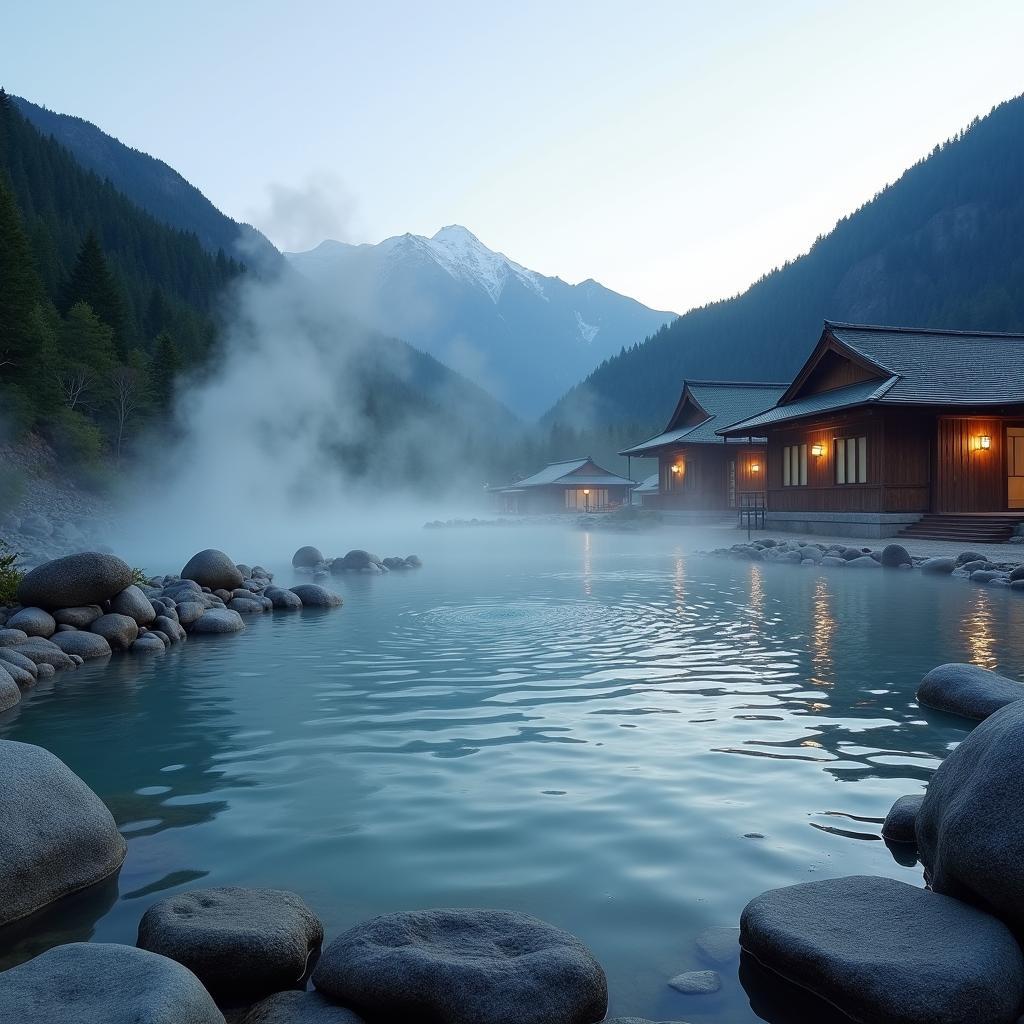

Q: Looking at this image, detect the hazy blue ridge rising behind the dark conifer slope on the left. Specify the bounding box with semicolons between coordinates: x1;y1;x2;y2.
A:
11;96;281;270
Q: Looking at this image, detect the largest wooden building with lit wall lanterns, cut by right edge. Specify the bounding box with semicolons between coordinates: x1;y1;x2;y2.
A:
719;321;1024;540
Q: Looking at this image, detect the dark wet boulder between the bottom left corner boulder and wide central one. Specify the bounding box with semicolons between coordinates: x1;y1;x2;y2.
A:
138;887;324;1002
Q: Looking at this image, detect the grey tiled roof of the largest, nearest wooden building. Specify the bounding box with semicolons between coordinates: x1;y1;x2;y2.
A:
720;321;1024;437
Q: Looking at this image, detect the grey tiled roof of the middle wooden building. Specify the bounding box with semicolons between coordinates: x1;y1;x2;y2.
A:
618;381;786;456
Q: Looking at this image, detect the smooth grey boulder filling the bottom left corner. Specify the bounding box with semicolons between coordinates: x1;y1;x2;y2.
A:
0;942;224;1024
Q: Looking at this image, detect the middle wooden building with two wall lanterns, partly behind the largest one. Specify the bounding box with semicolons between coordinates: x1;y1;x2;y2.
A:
620;381;785;512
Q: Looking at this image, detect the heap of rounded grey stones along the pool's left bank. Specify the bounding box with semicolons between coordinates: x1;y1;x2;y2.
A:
0;549;342;696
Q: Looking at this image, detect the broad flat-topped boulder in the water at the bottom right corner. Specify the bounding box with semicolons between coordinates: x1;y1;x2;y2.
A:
740;872;1024;1024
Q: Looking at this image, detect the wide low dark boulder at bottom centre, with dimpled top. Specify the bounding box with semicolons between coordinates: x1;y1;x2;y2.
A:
313;909;608;1024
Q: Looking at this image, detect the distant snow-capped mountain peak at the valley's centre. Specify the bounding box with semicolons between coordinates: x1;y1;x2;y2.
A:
286;225;675;416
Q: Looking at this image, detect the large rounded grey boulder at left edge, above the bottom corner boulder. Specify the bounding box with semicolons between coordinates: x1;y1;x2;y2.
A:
0;739;127;925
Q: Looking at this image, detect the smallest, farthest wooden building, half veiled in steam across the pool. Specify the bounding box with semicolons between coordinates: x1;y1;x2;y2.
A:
494;457;636;515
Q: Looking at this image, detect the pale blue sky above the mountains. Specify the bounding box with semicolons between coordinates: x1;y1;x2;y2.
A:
0;0;1024;311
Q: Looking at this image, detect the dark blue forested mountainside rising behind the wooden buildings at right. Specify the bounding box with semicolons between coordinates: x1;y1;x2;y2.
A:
546;90;1024;427
